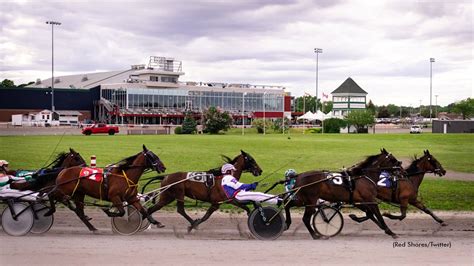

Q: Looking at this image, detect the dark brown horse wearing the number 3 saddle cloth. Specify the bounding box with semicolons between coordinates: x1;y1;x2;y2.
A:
285;149;401;239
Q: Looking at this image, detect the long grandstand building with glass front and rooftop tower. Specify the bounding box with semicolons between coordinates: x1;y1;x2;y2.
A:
0;56;292;125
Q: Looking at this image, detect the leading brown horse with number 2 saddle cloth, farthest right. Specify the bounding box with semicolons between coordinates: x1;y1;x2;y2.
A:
351;150;446;226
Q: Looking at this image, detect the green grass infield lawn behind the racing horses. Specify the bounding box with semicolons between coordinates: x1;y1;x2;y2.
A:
0;134;474;210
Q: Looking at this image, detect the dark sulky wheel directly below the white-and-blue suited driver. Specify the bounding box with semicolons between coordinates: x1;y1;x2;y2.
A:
248;206;285;240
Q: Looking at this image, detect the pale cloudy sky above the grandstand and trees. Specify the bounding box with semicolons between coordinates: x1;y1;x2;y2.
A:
0;0;474;107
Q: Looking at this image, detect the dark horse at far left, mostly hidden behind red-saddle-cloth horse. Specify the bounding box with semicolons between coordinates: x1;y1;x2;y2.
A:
10;148;86;191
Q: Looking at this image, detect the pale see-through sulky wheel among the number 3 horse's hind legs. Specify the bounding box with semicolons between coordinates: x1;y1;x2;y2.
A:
313;206;344;237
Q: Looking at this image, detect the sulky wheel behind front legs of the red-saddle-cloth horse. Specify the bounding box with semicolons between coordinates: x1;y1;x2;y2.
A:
112;205;142;236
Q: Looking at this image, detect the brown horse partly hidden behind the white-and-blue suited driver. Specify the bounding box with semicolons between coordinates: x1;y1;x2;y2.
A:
144;150;262;232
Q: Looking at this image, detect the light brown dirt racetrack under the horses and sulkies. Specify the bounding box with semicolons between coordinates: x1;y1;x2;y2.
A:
0;209;474;265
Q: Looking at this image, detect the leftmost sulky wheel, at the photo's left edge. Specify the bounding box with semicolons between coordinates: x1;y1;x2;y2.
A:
2;202;34;236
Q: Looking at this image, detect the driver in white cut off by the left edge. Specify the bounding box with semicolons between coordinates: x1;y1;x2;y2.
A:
0;160;38;201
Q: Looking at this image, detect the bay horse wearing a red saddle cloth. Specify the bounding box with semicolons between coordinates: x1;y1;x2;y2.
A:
45;145;166;231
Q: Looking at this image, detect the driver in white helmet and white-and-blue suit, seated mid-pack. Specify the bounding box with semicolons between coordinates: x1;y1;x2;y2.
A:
221;164;282;205
